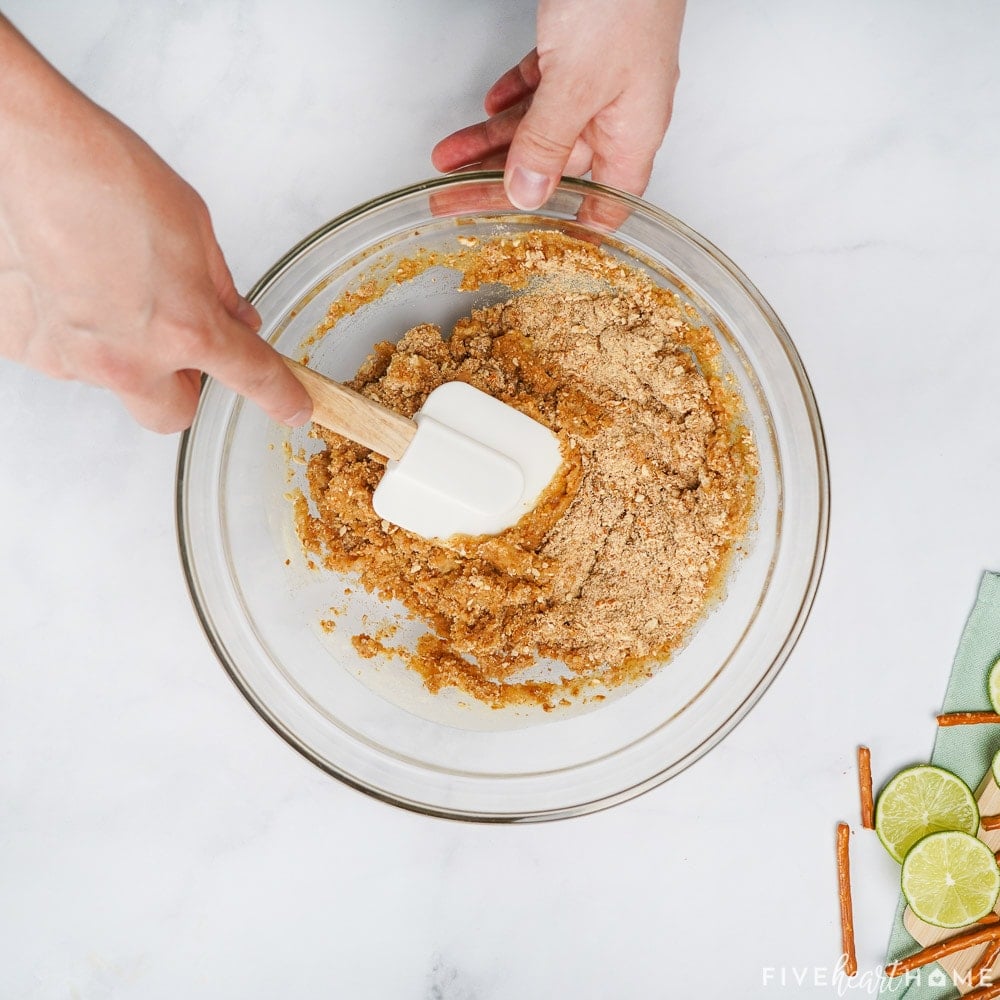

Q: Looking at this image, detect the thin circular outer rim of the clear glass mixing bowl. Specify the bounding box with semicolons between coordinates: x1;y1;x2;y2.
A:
174;170;831;823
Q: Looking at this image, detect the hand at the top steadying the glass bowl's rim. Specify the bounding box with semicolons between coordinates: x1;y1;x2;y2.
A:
431;0;684;210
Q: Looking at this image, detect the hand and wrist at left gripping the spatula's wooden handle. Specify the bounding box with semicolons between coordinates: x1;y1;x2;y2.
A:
0;18;312;433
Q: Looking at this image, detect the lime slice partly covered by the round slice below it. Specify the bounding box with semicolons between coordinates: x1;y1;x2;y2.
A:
875;764;979;861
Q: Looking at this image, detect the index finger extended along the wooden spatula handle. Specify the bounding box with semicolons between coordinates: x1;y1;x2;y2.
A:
196;313;312;427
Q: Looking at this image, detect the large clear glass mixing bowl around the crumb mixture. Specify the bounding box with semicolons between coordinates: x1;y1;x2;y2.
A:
177;173;829;821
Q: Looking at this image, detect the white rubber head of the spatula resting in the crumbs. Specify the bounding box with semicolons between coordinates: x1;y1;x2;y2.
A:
372;382;562;539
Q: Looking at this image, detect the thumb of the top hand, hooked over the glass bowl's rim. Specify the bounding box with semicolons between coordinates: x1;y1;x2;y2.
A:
504;77;592;211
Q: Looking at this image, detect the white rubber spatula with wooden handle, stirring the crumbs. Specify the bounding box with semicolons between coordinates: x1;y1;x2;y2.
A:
285;358;562;538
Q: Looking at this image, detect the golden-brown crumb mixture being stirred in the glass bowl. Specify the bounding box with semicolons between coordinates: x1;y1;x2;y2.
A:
295;232;757;708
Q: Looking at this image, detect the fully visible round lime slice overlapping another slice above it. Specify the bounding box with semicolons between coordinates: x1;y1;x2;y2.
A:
902;830;1000;927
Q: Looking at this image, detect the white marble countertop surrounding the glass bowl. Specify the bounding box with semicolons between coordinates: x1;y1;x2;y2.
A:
0;0;1000;1000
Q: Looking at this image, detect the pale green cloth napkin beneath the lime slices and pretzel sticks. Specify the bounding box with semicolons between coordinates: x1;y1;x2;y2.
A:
882;573;1000;1000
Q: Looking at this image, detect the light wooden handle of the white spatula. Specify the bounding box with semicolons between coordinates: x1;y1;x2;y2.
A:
285;358;417;460
